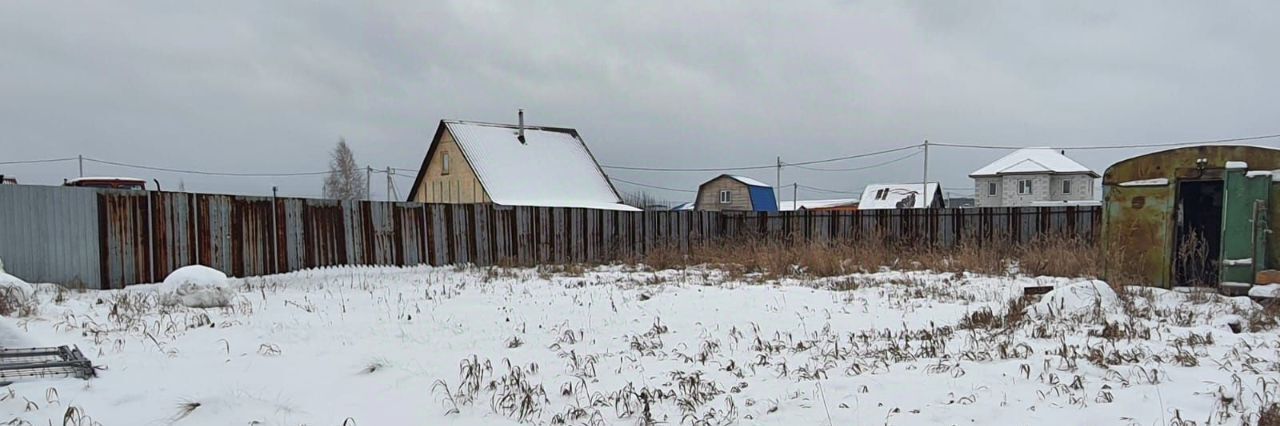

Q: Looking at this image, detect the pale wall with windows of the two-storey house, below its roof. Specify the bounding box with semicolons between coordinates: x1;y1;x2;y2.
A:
974;173;1094;207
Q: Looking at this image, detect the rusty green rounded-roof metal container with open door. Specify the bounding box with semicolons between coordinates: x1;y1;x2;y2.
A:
1102;145;1280;290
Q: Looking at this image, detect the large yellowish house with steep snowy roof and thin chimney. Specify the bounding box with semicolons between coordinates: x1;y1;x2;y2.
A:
408;114;639;211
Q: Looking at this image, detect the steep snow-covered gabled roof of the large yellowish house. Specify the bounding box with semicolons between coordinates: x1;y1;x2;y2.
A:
410;120;639;210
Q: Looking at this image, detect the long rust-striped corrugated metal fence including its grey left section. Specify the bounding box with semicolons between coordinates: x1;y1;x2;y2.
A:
0;185;1101;288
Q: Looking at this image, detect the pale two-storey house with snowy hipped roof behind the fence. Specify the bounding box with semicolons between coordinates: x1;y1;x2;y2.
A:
969;147;1098;207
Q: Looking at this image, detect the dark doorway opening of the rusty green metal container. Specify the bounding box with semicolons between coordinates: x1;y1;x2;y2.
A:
1172;180;1222;287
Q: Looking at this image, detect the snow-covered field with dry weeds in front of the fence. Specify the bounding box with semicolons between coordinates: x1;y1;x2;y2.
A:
0;266;1280;426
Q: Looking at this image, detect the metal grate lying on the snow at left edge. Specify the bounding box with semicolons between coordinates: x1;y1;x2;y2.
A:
0;345;97;386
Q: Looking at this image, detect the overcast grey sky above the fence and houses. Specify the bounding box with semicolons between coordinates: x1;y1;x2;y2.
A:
0;0;1280;201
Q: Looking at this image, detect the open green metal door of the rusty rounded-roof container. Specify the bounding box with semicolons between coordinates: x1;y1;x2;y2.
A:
1221;170;1271;284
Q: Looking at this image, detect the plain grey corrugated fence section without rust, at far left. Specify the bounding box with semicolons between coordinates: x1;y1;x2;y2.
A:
0;185;101;288
